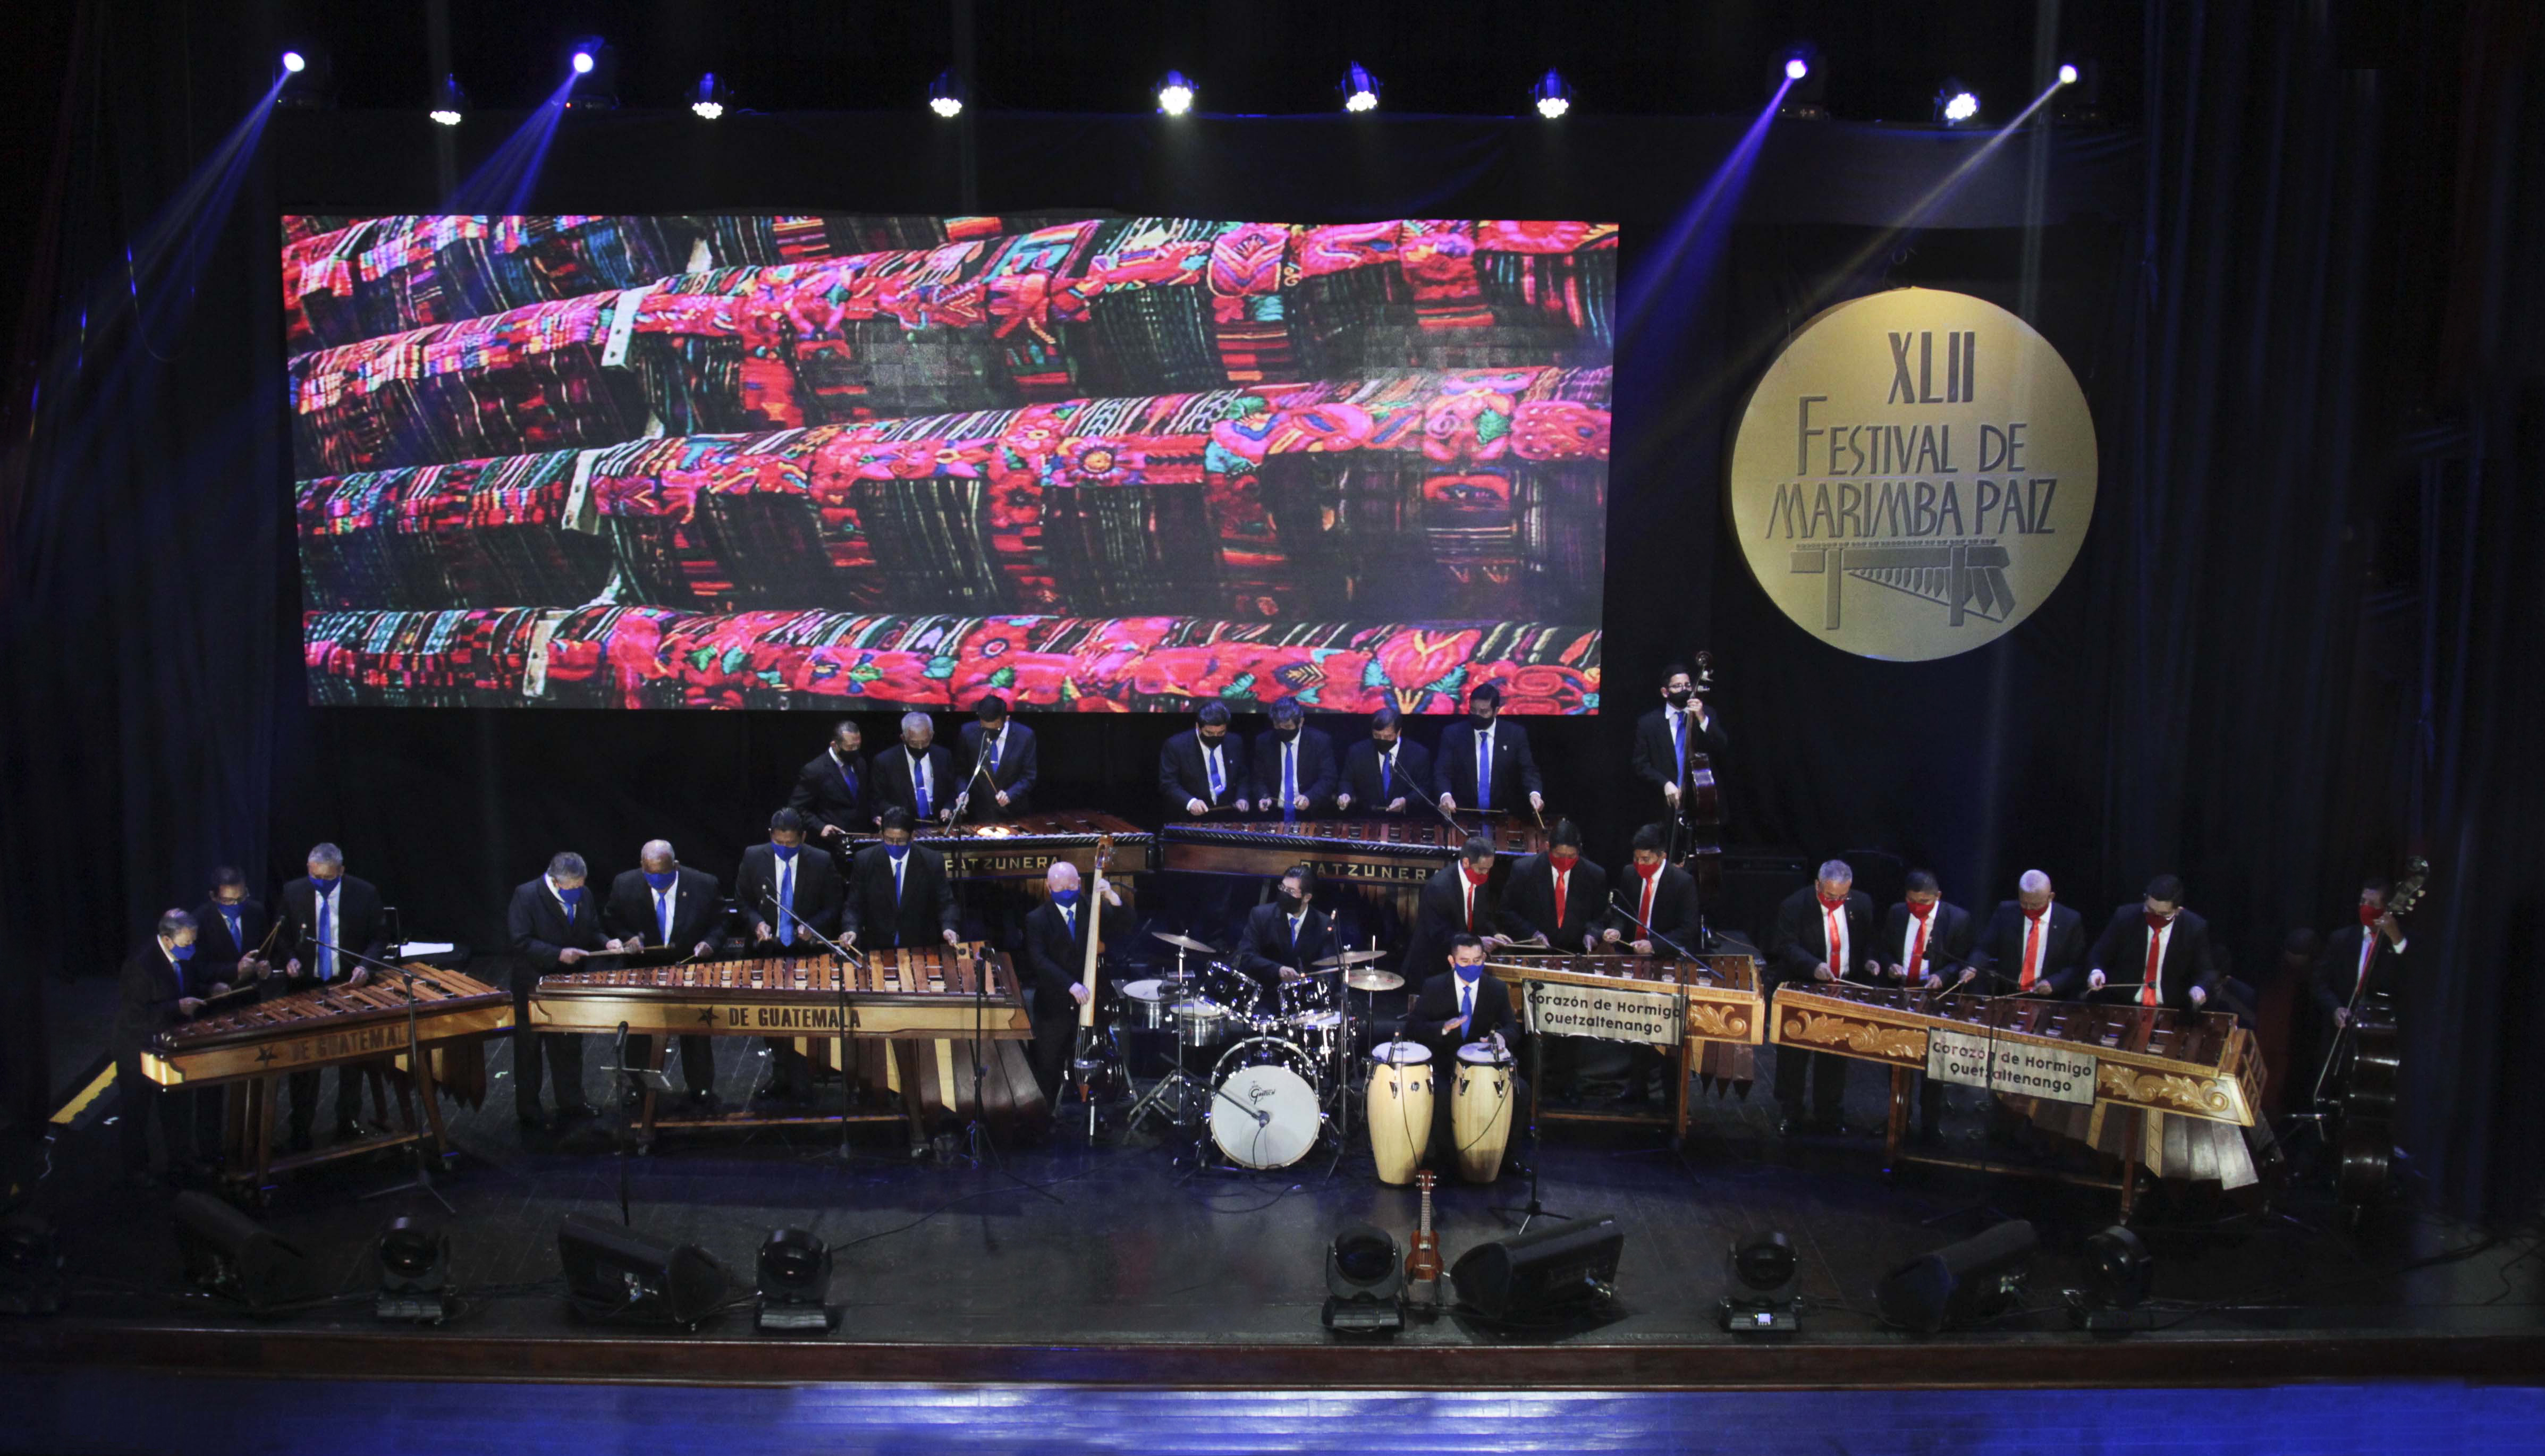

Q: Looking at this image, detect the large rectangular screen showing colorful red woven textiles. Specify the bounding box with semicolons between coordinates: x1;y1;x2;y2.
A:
283;214;1619;713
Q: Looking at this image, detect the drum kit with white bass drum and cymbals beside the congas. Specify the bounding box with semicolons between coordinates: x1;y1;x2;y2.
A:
1117;929;1428;1171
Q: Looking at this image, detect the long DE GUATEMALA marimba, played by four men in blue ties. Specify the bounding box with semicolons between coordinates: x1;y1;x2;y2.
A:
529;942;1043;1146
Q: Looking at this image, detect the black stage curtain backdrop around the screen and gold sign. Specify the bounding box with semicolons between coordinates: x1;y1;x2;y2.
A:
0;0;2545;1209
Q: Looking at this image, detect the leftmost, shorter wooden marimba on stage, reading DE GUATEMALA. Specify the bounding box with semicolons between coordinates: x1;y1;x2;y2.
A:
142;964;512;1189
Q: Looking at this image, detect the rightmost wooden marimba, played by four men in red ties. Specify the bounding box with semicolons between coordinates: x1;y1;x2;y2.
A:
1771;983;2262;1220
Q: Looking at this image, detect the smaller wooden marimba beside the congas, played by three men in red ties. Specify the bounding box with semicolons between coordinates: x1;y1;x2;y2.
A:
1486;950;1766;1138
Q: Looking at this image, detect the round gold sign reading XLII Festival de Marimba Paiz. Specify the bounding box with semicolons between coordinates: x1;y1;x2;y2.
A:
1726;287;2094;662
